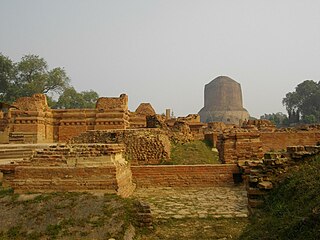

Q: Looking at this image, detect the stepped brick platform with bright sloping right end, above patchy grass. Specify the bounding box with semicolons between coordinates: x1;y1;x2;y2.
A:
4;144;135;197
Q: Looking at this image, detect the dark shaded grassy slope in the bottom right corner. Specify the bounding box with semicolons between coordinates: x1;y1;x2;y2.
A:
240;157;320;240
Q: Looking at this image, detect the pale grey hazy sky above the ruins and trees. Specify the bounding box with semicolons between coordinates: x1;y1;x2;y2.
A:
0;0;320;117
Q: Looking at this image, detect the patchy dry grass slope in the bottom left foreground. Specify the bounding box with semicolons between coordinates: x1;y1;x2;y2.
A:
0;186;141;240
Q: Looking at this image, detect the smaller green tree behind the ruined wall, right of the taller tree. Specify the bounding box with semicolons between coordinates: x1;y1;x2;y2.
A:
53;87;99;109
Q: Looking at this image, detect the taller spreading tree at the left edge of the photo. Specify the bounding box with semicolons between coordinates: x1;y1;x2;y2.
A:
0;54;70;103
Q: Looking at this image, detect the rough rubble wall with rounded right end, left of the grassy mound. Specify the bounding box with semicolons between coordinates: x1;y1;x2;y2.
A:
71;129;171;164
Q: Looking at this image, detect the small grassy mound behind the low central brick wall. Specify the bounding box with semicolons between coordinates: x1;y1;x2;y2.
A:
168;141;220;165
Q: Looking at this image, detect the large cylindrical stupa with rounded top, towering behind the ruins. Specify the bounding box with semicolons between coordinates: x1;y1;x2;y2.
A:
199;76;249;125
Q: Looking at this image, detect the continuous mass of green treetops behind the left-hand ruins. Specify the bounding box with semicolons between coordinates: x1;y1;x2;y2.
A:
0;53;99;108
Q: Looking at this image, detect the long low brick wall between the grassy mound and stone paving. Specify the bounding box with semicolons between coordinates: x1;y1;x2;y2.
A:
131;164;239;187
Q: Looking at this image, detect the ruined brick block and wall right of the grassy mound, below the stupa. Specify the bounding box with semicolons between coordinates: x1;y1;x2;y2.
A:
217;120;320;163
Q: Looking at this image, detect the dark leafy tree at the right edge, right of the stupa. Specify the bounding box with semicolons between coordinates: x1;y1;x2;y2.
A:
282;80;320;123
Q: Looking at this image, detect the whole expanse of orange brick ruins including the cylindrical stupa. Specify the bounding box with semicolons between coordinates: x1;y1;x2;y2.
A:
0;77;320;216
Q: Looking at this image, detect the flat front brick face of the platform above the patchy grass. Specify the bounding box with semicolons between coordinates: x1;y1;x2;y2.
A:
12;166;118;193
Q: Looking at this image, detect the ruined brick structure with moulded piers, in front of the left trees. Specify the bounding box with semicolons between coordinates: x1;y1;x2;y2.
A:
0;94;160;143
